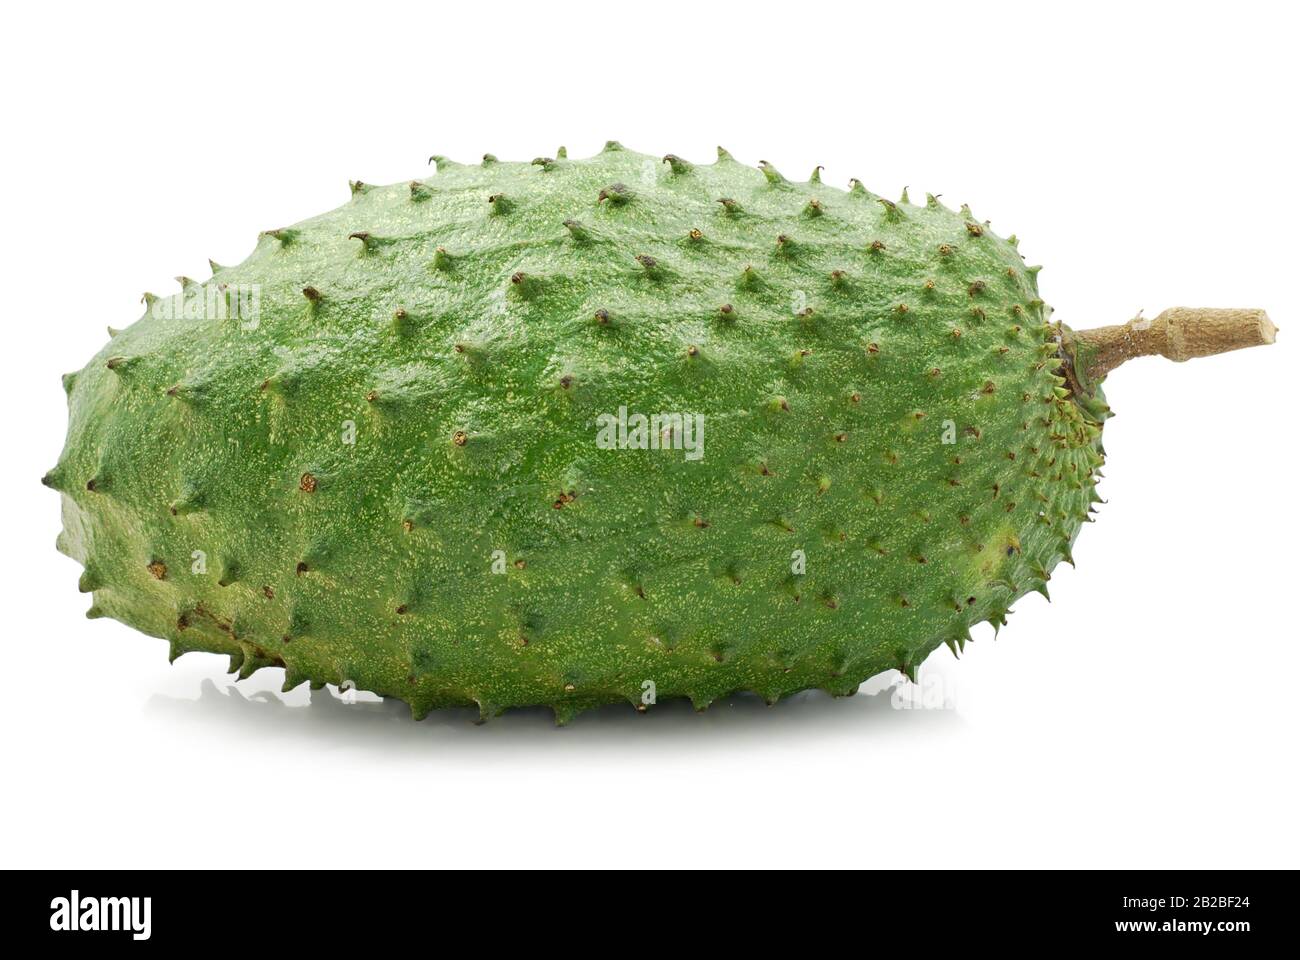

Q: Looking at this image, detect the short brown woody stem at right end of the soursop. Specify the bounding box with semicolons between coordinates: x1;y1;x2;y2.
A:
1073;307;1278;381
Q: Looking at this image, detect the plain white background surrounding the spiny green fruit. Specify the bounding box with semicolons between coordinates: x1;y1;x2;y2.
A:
0;0;1300;868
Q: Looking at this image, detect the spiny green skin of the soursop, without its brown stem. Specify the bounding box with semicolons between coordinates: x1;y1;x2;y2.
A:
46;143;1106;722
